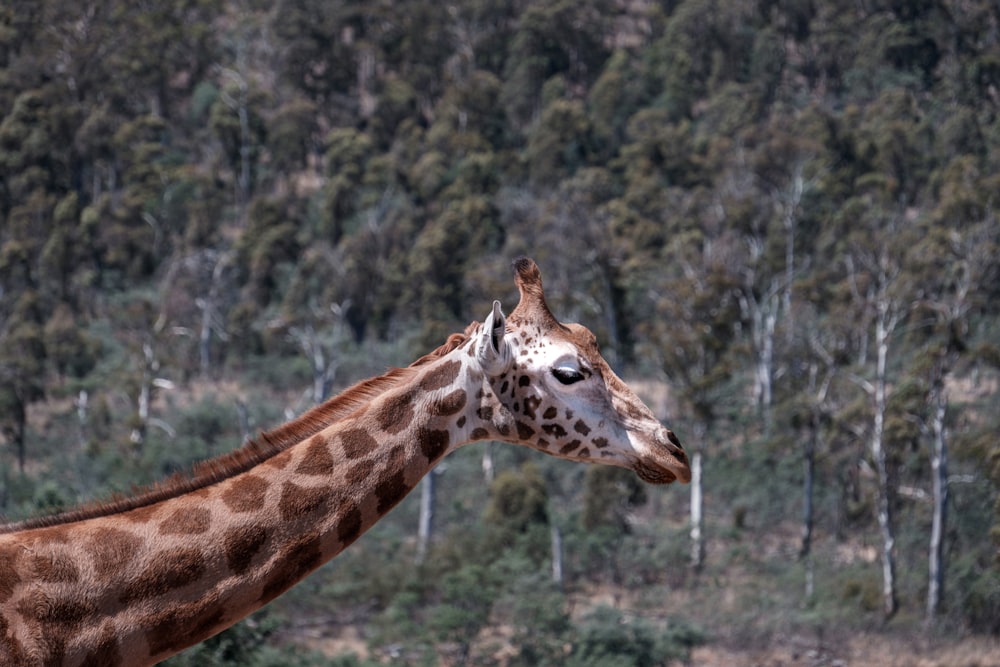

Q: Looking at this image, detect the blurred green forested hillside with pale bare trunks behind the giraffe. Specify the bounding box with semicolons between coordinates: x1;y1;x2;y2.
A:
0;0;1000;667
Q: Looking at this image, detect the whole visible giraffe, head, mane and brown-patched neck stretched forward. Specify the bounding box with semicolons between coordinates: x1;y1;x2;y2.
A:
0;258;691;667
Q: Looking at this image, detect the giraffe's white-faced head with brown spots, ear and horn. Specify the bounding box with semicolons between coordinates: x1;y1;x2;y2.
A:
474;258;691;484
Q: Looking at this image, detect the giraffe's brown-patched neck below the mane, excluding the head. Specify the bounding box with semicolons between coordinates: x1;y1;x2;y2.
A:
0;346;488;665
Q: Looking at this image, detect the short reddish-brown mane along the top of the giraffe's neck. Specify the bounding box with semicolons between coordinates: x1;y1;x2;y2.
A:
0;322;470;534
